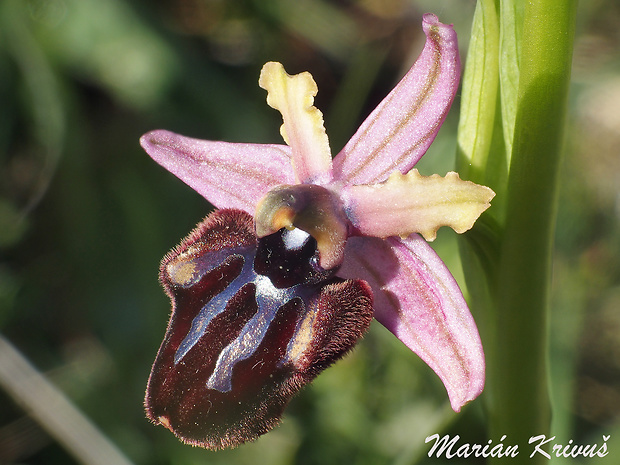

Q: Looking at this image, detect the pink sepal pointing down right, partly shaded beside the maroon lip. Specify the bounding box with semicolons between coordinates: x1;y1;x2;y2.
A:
338;234;485;412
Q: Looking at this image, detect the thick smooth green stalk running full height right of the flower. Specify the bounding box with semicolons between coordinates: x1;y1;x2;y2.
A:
489;0;577;465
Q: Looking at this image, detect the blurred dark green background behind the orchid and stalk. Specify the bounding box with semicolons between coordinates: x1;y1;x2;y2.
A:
0;0;620;465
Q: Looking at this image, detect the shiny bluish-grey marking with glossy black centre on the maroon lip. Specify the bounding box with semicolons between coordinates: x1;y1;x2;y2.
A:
174;229;335;392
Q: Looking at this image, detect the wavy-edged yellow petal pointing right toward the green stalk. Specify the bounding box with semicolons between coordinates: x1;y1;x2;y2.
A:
343;169;495;241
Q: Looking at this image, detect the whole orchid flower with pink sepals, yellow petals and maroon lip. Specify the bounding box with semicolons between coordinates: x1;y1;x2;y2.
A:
141;14;494;449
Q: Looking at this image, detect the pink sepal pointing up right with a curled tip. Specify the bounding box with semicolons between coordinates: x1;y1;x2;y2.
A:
333;13;461;185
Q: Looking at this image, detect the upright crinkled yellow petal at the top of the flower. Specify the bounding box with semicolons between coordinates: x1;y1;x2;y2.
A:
258;62;332;184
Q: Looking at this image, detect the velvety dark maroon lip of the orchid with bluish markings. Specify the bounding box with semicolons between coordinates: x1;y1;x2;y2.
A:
145;210;372;449
